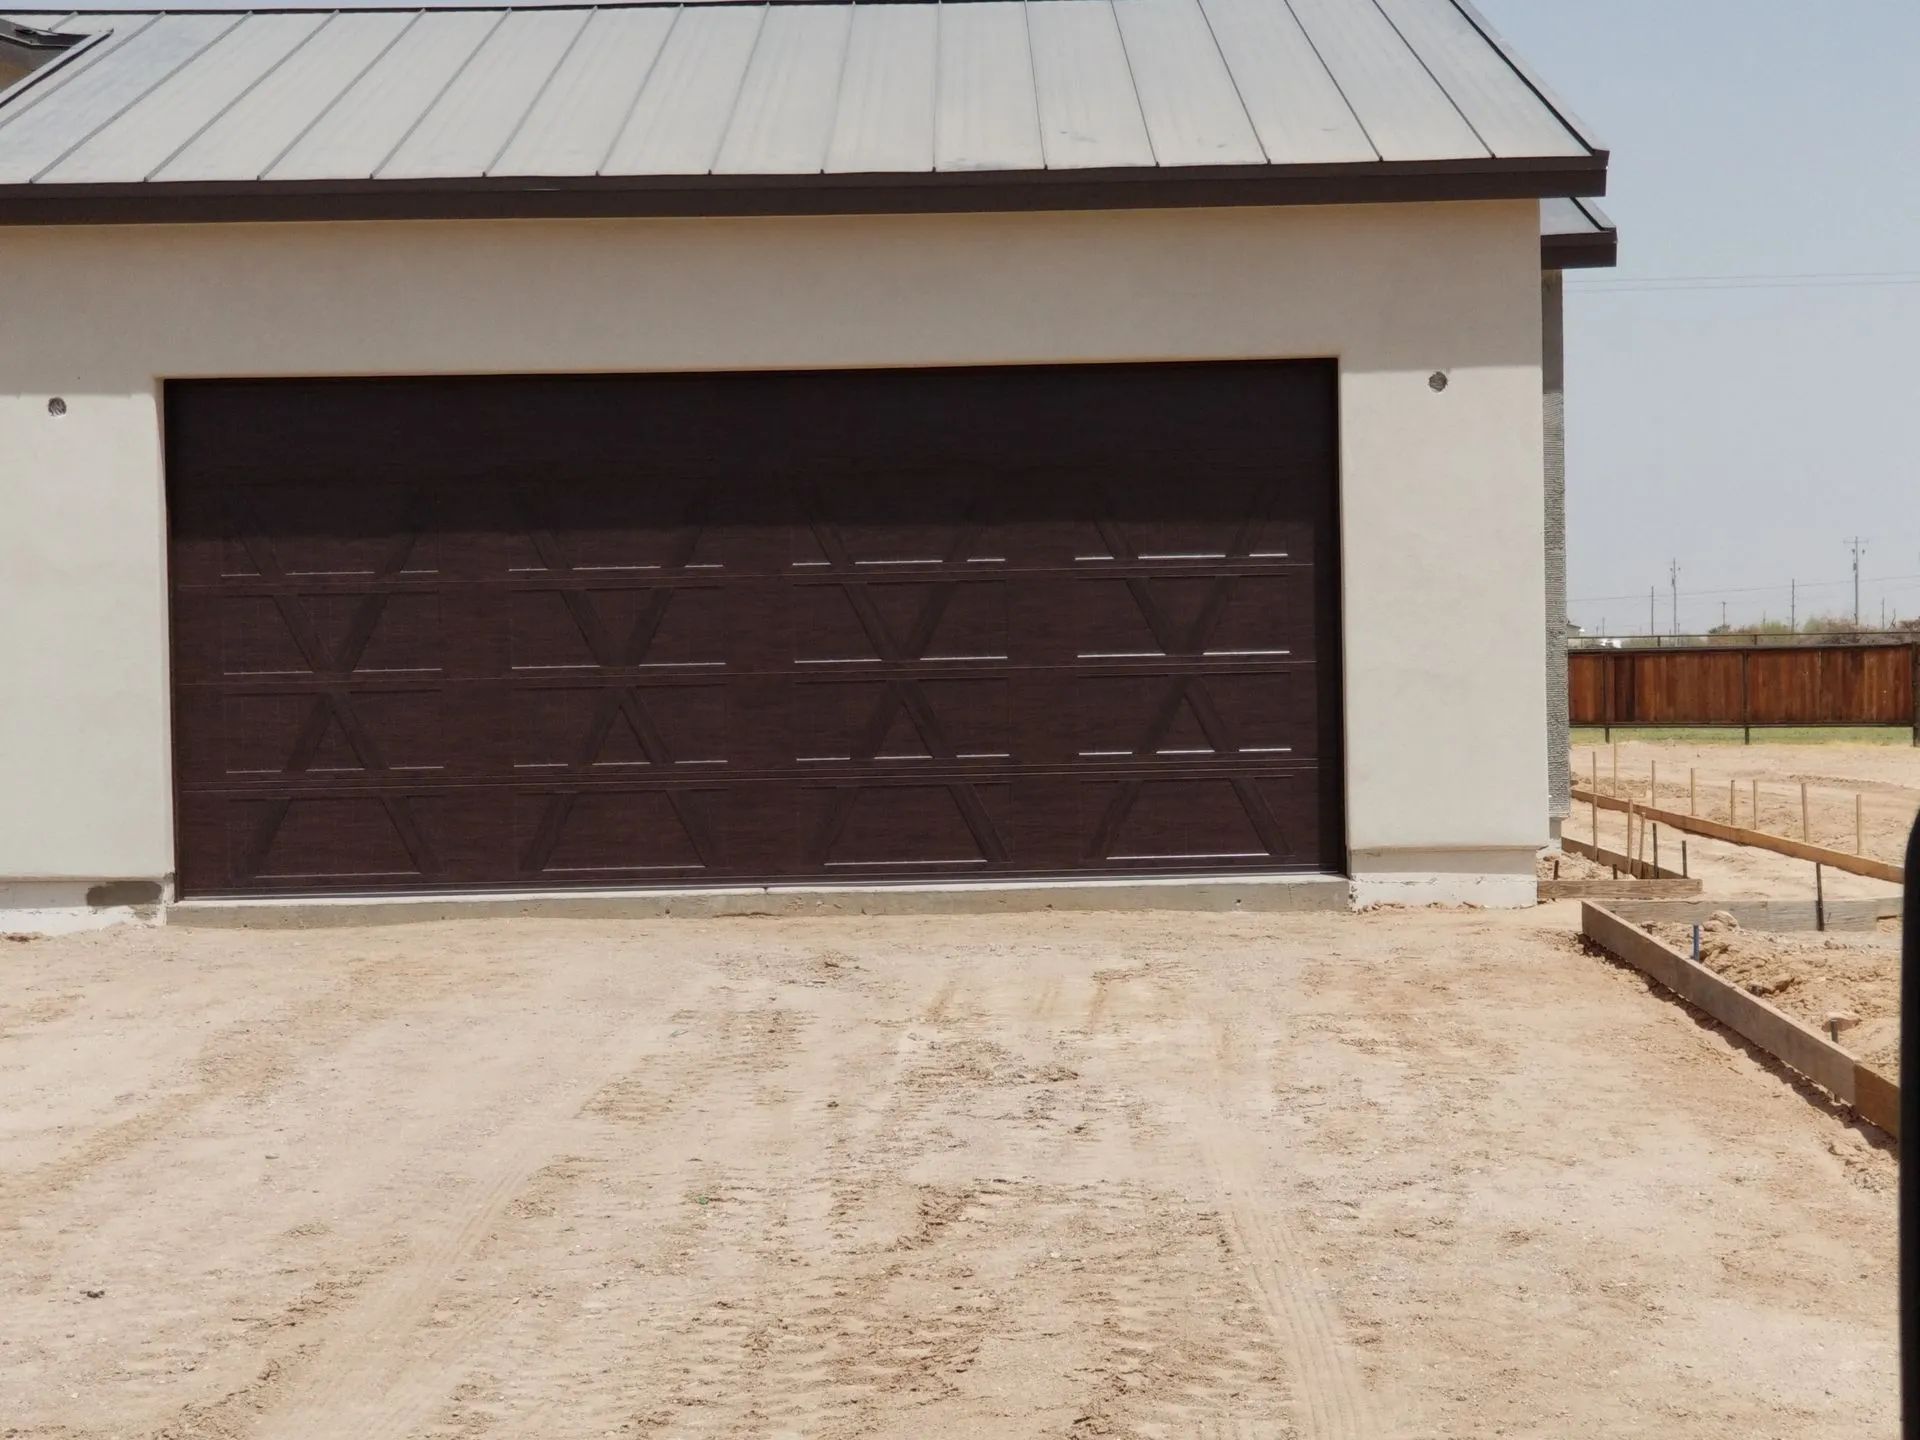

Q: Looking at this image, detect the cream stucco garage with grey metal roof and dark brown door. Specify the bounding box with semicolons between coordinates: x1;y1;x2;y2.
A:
0;0;1589;931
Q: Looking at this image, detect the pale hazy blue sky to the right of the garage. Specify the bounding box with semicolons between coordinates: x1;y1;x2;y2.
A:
1480;0;1920;630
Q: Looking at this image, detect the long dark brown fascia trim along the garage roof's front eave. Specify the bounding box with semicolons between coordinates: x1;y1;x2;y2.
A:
0;156;1607;225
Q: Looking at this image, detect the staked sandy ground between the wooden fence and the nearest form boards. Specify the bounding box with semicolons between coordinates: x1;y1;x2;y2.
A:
1567;741;1920;900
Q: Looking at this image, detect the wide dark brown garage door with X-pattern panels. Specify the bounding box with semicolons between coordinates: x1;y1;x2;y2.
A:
167;363;1344;895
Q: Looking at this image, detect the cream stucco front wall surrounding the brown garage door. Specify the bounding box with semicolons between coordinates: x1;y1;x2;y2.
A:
0;202;1546;906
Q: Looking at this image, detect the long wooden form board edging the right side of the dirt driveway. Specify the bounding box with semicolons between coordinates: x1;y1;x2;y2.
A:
1580;902;1899;1135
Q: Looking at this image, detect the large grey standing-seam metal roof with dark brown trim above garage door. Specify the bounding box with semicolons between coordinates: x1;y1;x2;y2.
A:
0;0;1607;223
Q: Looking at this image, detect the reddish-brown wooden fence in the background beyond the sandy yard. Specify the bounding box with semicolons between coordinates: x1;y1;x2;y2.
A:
1567;645;1920;745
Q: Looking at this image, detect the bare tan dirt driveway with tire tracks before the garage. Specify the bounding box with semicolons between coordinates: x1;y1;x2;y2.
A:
0;912;1895;1440
